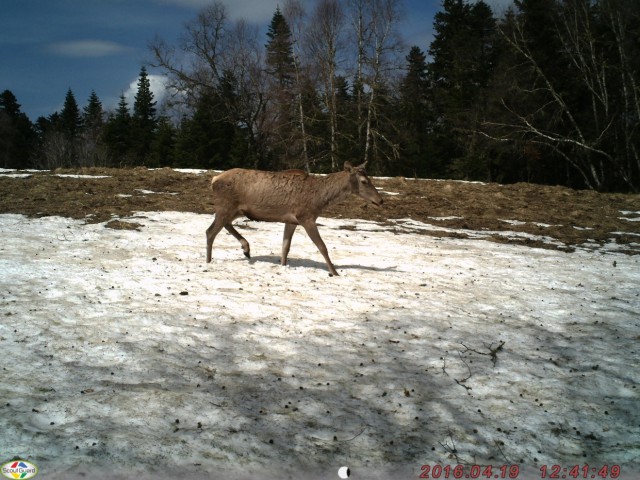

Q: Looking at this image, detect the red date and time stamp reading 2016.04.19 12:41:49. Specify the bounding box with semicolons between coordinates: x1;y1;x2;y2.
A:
418;464;622;480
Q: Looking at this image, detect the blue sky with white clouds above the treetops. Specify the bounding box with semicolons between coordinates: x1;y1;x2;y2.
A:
0;0;511;121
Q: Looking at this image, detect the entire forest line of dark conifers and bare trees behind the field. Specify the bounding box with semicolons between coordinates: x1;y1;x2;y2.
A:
0;0;640;192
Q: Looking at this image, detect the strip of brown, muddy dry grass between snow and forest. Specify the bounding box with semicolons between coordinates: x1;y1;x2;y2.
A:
0;168;640;254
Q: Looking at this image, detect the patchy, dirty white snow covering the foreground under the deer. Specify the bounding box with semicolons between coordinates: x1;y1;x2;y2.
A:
0;212;640;480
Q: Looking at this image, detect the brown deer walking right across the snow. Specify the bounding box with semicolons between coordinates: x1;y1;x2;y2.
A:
207;162;383;277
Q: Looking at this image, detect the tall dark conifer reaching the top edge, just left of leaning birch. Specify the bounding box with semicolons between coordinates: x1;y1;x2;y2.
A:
429;0;497;180
